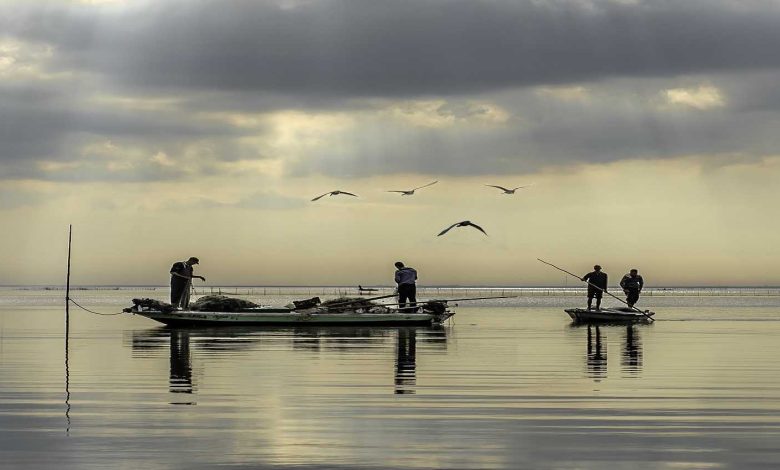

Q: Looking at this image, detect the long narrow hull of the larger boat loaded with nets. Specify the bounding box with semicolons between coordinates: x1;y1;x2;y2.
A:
128;305;455;326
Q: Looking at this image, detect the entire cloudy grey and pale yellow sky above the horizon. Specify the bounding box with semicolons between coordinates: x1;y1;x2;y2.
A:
0;0;780;285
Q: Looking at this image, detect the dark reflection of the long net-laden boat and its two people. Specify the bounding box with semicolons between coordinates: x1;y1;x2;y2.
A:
130;326;447;405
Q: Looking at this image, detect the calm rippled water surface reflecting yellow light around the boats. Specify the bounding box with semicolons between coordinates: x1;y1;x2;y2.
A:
0;289;780;469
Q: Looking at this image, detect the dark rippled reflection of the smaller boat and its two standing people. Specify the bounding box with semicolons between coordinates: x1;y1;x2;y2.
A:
571;324;643;382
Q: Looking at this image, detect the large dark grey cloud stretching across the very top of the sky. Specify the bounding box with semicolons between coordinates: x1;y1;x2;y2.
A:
2;0;780;96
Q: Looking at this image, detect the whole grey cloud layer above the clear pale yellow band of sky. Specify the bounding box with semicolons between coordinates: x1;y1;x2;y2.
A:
0;0;780;181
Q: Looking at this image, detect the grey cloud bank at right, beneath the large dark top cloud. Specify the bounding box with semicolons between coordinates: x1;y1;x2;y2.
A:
291;74;780;177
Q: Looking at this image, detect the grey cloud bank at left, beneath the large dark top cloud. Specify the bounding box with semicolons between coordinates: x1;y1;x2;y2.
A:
0;80;274;181
